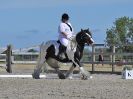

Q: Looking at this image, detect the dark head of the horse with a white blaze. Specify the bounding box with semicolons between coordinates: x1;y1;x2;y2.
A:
76;29;94;45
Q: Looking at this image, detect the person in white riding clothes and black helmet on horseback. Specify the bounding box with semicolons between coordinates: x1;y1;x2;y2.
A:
58;13;73;56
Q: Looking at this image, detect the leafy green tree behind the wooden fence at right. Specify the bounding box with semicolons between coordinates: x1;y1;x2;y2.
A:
106;16;133;51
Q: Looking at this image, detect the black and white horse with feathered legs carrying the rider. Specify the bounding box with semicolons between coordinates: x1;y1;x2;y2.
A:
32;29;94;80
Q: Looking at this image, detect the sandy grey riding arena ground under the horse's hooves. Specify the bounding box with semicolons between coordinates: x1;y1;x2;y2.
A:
0;63;133;99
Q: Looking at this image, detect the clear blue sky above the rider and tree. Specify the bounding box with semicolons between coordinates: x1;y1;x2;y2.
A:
0;0;133;48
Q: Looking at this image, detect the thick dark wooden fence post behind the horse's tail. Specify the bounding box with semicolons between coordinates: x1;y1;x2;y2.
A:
6;45;12;73
